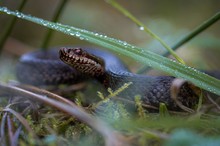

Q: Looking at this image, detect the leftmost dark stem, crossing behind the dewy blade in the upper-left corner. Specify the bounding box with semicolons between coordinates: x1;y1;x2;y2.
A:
0;0;27;54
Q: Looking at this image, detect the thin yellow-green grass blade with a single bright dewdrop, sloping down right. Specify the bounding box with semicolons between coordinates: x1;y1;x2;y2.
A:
106;0;185;64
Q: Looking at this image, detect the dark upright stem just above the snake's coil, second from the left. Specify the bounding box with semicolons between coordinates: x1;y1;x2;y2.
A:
41;0;68;50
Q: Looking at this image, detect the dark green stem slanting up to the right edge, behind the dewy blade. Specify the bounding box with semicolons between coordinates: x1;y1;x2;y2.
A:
137;12;220;73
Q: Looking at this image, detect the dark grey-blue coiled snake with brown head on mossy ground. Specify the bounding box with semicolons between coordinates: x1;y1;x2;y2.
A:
16;47;215;110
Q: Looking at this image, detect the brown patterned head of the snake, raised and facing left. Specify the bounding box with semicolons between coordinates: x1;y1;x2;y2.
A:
59;48;105;76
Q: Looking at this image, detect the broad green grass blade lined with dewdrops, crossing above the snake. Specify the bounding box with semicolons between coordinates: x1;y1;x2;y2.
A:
0;7;220;95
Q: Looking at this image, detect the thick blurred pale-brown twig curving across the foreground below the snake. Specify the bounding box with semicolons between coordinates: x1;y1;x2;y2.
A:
0;82;129;146
